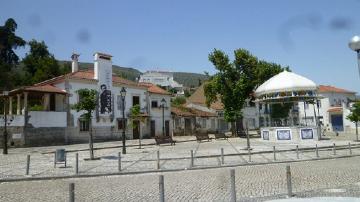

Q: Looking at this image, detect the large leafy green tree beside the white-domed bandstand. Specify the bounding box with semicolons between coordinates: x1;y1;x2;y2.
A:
204;49;283;133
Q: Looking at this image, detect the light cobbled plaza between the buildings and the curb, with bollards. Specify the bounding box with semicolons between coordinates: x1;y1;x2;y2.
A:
0;137;360;181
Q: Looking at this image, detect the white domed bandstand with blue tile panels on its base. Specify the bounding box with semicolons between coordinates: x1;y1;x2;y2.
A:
255;71;320;142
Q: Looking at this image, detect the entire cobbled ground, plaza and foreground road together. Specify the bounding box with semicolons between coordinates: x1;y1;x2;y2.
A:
0;134;360;201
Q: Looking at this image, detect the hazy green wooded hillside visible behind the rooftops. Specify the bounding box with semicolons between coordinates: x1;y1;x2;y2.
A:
59;61;208;87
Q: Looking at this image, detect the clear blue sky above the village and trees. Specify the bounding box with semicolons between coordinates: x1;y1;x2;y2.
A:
0;0;360;92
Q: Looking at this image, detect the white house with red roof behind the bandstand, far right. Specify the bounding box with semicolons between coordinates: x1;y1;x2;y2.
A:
298;85;356;133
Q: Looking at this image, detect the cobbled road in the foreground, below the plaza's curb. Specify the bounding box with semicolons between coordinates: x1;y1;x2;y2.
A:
0;157;360;201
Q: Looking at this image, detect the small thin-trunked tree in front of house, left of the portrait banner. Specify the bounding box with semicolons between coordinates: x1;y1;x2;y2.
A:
72;89;97;160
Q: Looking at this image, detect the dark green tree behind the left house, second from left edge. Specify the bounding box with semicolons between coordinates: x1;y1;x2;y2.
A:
23;39;63;84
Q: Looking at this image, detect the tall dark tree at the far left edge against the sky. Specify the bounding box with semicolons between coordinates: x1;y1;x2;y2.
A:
0;18;26;89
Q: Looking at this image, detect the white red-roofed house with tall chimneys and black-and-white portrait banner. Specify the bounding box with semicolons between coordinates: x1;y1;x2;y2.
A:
0;52;172;146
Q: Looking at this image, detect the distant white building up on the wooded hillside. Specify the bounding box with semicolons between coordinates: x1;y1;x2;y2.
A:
139;71;184;95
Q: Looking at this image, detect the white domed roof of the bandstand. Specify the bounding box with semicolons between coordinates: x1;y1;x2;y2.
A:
255;71;317;97
